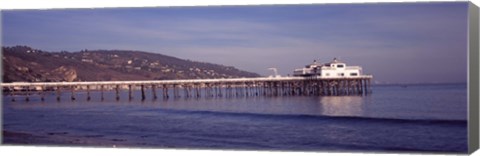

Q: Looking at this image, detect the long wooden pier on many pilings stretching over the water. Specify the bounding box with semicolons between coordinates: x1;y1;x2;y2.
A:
1;75;372;101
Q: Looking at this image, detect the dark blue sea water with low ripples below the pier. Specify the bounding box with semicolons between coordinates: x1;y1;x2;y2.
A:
3;84;467;153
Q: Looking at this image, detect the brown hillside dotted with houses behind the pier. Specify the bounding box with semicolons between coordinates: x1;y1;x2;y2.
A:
2;46;259;82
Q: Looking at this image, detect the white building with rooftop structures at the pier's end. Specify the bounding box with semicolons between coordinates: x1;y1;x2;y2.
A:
293;58;362;78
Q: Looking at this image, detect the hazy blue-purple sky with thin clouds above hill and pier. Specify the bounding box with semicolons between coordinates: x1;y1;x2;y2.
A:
1;2;468;83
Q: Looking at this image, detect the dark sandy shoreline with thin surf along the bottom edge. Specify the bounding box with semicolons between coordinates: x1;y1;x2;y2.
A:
2;130;465;154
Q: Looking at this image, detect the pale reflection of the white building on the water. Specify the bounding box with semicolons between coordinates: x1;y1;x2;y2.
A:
318;96;365;116
